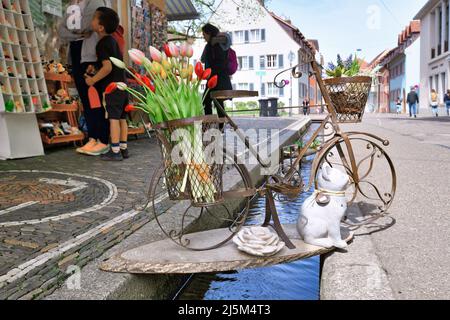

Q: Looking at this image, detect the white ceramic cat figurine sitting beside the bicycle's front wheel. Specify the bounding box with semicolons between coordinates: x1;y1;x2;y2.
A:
297;164;350;249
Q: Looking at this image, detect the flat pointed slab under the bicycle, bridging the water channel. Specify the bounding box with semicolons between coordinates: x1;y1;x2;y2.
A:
100;225;353;274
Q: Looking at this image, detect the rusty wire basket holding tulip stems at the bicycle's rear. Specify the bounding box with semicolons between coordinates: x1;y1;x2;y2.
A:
155;115;224;207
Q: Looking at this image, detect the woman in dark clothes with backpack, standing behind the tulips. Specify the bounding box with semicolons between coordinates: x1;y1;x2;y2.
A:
201;23;233;118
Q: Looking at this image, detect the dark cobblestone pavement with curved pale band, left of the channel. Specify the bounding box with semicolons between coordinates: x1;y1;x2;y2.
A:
0;139;161;298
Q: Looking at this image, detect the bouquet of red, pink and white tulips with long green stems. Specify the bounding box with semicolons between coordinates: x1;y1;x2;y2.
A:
110;43;218;203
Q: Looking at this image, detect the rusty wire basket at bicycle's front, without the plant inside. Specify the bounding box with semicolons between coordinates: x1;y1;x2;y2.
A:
324;77;372;123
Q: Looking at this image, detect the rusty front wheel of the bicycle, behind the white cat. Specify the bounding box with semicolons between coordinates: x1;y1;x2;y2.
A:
312;133;397;226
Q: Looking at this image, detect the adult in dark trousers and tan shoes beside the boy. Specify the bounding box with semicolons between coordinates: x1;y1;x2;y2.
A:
58;0;111;156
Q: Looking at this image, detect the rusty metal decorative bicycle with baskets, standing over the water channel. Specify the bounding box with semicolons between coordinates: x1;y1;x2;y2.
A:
148;50;396;251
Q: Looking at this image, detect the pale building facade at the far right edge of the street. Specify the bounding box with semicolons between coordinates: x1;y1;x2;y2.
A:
414;0;450;108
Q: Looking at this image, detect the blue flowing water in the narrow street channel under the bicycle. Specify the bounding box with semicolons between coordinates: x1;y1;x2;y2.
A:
179;159;320;300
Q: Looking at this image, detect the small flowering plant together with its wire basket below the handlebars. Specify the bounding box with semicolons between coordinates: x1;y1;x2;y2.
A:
324;55;372;122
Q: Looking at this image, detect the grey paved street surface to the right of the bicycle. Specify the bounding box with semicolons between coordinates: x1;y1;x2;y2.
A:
322;114;450;299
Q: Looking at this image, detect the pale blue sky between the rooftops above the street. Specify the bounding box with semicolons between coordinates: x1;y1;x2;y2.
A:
268;0;427;62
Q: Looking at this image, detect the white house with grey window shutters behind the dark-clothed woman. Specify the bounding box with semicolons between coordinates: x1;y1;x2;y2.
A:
190;0;319;112
